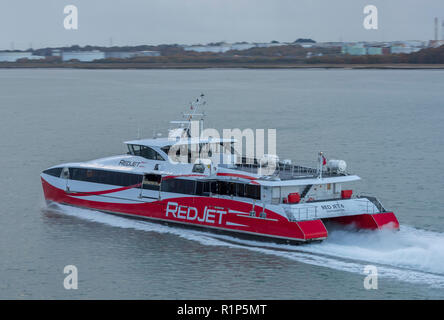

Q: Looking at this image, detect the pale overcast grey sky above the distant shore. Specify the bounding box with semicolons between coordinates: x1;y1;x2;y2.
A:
0;0;444;49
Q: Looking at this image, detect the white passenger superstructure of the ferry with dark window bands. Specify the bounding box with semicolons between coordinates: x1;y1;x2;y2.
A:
44;133;359;205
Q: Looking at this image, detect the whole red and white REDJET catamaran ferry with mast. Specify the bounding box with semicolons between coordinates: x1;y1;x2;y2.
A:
41;95;399;243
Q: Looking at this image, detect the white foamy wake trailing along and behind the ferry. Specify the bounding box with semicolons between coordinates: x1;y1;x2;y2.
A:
44;205;444;288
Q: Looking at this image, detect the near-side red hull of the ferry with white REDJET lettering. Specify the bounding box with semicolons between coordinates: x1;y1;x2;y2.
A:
42;178;328;241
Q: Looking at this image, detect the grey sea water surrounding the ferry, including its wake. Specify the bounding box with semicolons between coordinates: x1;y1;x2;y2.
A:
0;70;444;299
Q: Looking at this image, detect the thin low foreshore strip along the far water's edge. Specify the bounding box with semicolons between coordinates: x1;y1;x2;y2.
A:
0;62;444;70
